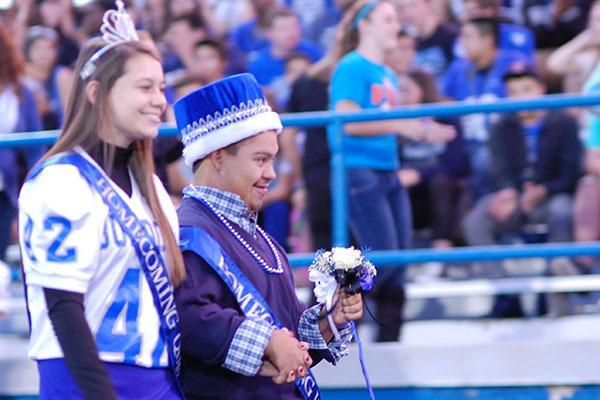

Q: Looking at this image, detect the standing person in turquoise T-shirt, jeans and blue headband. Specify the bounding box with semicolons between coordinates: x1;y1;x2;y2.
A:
329;1;455;341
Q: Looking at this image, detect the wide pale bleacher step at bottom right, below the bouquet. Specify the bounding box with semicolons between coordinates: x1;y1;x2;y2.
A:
314;315;600;399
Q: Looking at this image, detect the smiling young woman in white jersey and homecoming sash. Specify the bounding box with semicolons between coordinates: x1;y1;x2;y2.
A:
19;2;184;399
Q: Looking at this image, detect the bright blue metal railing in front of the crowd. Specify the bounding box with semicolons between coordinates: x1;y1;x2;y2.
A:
0;94;600;265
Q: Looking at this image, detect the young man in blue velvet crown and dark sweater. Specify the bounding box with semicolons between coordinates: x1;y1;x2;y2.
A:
175;74;362;399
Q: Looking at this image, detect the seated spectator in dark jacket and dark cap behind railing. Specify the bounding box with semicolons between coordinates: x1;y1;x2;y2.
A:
464;63;581;317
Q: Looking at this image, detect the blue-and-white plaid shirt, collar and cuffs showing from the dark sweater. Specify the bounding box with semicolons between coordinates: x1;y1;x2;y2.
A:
183;185;352;376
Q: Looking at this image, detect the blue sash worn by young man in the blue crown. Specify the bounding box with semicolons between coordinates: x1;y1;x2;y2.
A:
179;226;321;400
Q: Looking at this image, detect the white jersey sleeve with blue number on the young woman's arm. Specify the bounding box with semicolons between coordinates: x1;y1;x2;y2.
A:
19;165;102;293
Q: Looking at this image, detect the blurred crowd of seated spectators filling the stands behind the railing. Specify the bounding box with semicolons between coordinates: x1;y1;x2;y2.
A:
0;0;600;315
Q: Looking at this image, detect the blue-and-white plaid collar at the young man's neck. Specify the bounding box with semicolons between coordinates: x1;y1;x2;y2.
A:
183;185;258;237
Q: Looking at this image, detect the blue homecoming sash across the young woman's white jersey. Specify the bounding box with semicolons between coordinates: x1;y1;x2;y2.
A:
27;153;183;396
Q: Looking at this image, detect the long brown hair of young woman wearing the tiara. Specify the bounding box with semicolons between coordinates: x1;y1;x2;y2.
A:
43;39;185;285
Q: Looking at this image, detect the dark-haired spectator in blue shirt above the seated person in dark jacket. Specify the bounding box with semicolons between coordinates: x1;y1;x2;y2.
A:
442;18;526;199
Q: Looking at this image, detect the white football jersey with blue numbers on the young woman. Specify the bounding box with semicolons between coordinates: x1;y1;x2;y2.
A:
19;149;179;367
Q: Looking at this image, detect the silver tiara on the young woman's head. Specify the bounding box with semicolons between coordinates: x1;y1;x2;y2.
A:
79;0;139;79
